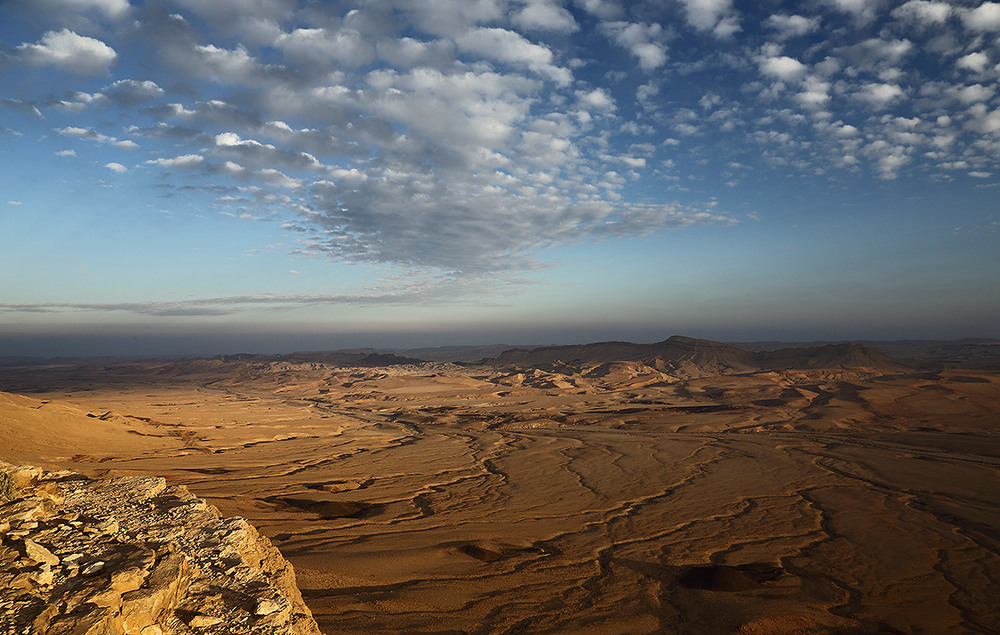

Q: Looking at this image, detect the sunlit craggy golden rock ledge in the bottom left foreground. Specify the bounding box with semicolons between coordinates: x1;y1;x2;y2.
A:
0;462;319;635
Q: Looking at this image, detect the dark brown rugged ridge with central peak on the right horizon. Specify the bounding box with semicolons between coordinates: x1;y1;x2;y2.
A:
485;335;907;374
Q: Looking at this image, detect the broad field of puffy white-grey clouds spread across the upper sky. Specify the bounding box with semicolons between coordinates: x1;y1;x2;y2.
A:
0;0;1000;286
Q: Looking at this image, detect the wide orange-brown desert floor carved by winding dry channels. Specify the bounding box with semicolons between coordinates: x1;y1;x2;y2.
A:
0;361;1000;633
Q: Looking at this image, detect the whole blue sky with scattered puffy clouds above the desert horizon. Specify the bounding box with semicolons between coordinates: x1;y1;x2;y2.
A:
0;0;1000;354
